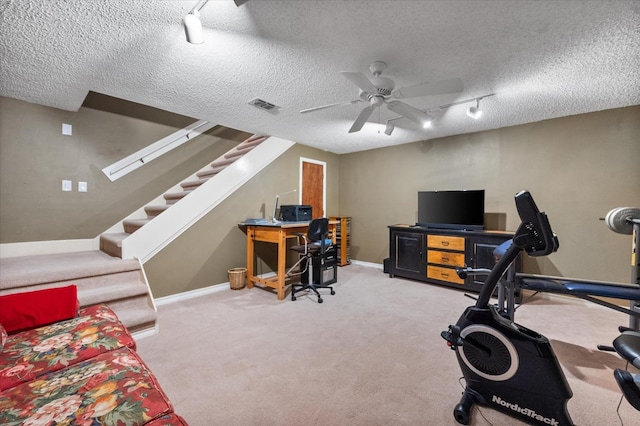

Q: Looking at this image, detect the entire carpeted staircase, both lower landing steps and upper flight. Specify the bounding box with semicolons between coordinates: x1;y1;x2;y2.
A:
0;136;267;333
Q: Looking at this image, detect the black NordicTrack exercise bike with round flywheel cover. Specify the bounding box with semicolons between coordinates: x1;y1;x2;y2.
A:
441;191;640;425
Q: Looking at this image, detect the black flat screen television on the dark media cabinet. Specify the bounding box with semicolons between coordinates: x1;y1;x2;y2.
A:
416;189;484;231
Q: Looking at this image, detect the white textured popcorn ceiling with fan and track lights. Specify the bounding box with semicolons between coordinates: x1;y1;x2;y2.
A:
0;0;640;153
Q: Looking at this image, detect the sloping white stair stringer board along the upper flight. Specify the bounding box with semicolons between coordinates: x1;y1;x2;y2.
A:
122;137;295;264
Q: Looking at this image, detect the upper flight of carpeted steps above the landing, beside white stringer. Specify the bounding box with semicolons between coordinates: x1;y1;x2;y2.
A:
100;136;267;258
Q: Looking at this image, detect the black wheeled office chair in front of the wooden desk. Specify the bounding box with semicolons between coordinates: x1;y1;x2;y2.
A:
287;218;337;303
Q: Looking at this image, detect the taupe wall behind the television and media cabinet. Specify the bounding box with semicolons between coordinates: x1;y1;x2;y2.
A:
340;106;640;282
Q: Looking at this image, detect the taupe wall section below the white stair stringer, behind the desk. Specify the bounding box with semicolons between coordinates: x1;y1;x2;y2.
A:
145;144;340;297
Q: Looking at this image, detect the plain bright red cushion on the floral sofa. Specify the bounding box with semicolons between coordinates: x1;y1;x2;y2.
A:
0;285;78;333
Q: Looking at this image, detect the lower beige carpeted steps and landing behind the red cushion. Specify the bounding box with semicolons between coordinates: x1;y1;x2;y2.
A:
0;250;156;332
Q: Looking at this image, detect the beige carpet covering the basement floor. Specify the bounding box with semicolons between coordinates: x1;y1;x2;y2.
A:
138;265;640;426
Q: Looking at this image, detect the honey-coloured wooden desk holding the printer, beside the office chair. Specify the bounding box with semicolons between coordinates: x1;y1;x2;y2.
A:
240;220;338;300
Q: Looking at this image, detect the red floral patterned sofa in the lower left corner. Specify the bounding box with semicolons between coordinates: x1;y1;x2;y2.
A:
0;305;187;426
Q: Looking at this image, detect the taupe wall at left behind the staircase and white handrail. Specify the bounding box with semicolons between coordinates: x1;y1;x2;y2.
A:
0;96;248;243
